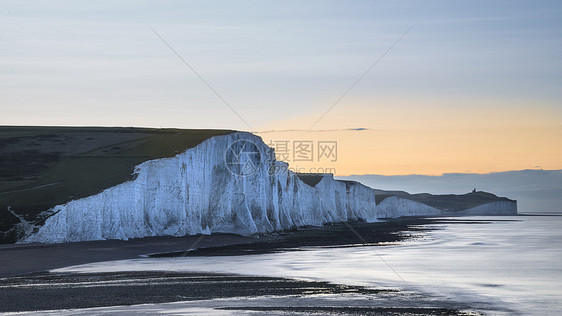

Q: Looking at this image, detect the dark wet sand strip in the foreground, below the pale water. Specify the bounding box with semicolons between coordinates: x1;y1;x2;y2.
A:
0;271;476;315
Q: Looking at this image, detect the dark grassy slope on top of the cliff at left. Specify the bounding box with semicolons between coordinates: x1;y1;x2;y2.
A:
0;126;233;239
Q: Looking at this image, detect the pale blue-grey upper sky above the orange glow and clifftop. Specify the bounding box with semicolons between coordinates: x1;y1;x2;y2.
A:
0;1;562;130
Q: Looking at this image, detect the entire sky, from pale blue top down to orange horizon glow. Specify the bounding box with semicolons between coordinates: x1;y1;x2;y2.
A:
0;0;562;175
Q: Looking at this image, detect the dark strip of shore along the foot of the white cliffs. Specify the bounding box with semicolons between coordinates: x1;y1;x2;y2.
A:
0;217;450;278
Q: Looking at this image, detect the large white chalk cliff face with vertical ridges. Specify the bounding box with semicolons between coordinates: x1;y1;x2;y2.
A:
22;132;512;243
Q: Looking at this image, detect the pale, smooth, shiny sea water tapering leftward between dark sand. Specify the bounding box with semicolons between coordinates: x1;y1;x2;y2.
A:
53;216;562;315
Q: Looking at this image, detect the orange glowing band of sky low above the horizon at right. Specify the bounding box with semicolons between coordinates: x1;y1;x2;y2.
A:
257;98;562;176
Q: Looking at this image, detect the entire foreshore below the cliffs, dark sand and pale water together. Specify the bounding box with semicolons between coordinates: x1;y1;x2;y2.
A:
0;215;562;315
